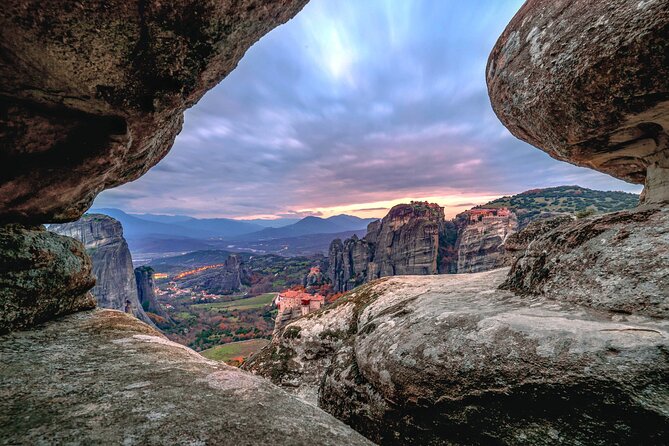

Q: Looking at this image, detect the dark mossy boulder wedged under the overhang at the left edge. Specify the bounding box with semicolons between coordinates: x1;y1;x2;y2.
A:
0;224;95;333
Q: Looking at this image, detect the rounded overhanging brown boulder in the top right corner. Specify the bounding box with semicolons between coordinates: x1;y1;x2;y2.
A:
487;0;669;202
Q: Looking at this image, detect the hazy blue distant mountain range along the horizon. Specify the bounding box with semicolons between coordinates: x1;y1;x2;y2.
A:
88;208;374;254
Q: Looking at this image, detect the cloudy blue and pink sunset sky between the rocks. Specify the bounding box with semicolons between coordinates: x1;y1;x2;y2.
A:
94;0;641;218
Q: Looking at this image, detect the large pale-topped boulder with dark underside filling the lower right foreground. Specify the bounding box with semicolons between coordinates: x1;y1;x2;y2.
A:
244;269;669;445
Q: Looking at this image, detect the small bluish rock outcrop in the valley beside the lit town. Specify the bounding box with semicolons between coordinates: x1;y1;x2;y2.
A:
183;254;250;294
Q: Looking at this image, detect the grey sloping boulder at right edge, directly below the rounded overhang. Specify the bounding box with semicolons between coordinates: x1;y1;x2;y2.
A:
503;206;669;318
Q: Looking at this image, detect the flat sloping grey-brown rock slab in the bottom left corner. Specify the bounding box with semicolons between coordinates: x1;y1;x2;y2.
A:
0;310;371;446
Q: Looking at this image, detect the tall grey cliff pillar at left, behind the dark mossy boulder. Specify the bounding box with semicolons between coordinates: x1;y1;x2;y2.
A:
49;214;152;323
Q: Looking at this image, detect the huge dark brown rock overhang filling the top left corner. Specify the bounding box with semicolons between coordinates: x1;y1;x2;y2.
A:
0;0;307;223
